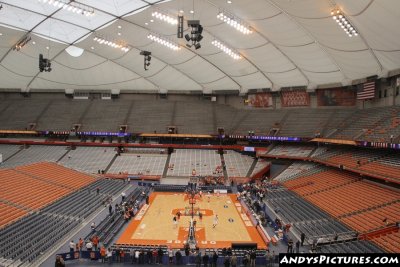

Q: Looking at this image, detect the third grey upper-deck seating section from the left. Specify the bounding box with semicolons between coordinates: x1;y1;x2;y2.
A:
80;100;130;132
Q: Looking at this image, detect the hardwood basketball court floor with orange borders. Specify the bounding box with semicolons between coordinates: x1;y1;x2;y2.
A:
116;192;266;249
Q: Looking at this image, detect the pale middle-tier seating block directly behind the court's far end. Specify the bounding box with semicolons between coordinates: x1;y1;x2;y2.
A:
167;149;221;176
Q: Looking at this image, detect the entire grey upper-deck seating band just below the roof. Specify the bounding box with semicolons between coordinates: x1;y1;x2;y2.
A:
0;97;400;142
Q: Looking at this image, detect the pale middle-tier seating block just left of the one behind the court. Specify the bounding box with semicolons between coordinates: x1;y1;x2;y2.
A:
108;153;167;175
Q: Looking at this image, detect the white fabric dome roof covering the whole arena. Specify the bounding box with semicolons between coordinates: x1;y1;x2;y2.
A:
0;0;400;91
